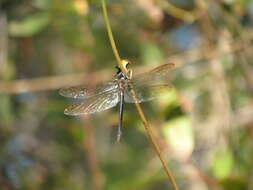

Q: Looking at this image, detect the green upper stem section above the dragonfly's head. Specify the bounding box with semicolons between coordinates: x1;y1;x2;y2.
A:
101;0;121;65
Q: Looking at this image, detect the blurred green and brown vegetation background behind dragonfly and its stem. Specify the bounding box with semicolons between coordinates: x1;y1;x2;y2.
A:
0;0;253;190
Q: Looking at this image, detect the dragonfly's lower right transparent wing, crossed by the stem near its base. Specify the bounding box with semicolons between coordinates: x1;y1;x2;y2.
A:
124;84;172;103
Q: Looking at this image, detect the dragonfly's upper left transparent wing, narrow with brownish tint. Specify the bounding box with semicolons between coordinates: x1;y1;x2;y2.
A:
59;81;118;99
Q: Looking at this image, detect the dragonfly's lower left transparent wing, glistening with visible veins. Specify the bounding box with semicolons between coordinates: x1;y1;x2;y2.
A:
64;90;119;115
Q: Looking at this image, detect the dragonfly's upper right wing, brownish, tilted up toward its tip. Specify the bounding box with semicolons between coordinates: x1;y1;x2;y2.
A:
131;63;175;88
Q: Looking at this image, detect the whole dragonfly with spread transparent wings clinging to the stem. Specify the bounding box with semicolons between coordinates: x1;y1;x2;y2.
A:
59;60;174;141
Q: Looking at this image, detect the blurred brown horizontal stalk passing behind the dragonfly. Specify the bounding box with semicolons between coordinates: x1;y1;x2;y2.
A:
0;35;253;94
